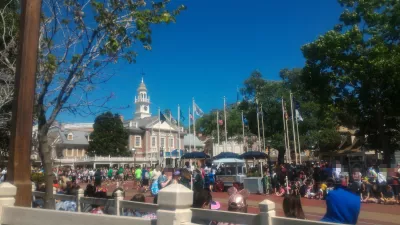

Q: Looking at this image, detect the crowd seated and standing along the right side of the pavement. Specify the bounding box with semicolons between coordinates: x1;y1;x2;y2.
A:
263;163;400;204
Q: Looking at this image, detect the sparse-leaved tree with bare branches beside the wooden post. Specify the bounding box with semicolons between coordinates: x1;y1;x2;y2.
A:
35;0;185;208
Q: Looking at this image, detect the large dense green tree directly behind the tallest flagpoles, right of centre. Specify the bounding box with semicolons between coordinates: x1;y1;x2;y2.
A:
240;68;340;161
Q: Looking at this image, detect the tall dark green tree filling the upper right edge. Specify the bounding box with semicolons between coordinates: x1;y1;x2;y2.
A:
302;0;400;163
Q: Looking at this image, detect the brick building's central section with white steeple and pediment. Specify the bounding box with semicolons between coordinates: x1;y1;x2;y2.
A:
123;79;185;165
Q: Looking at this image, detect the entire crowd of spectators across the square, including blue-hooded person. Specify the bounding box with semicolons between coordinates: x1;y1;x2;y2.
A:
21;161;400;225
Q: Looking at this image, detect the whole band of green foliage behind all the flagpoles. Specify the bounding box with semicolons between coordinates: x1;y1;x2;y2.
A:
196;69;341;158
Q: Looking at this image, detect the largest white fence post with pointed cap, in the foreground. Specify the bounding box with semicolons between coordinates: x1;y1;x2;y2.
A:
157;184;193;225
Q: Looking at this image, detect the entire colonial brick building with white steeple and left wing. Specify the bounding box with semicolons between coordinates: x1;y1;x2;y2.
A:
32;79;191;166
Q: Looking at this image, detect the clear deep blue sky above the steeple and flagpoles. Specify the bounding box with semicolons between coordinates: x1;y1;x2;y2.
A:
58;0;342;122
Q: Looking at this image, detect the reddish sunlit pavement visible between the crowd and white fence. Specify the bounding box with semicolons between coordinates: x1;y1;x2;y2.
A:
80;181;400;225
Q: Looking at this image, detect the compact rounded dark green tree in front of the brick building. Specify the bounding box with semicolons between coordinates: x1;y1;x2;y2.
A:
88;112;131;156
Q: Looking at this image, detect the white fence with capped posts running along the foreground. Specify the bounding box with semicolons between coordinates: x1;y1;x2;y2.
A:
0;183;338;225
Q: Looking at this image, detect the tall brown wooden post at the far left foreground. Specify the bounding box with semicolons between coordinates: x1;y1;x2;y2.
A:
7;0;42;207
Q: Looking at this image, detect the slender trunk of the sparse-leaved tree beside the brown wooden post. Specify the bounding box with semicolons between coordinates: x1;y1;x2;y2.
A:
38;128;55;209
